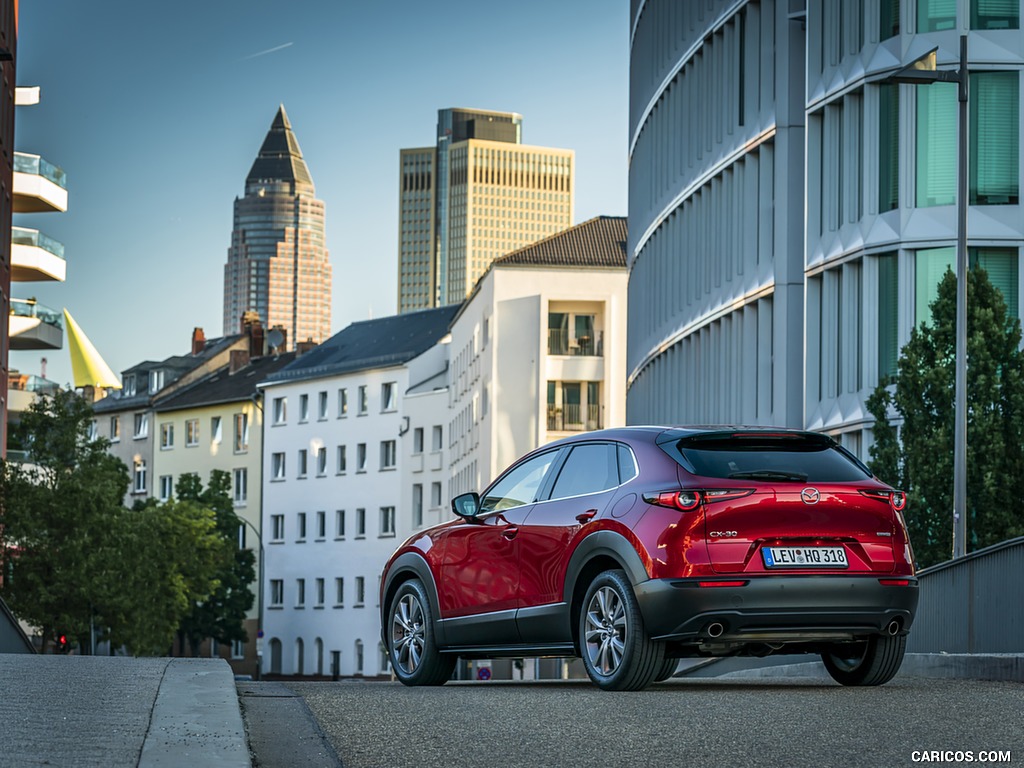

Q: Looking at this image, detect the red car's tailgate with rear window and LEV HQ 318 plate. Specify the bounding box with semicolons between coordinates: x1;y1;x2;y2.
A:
681;433;895;573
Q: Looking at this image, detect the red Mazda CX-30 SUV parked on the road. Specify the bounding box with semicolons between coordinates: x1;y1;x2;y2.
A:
380;427;918;690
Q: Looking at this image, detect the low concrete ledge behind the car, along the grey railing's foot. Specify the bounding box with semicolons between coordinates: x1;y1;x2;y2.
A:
703;653;1024;682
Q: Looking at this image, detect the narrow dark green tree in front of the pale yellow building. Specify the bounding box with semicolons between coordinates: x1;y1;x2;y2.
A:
176;469;256;654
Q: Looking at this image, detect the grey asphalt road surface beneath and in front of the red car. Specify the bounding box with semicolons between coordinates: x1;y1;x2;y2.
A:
288;677;1024;768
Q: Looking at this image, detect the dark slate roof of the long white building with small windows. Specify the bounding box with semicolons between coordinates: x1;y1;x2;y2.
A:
266;304;461;383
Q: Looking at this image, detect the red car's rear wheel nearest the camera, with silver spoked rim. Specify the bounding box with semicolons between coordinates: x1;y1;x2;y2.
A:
579;570;666;690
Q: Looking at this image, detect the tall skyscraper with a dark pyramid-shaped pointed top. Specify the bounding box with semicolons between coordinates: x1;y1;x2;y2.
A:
224;104;331;347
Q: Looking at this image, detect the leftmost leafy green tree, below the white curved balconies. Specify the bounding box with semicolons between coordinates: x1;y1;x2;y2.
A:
0;392;129;651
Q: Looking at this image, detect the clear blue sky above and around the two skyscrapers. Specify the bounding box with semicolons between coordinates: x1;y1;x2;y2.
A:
10;0;629;384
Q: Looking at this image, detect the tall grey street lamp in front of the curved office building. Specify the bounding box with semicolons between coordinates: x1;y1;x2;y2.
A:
887;35;970;560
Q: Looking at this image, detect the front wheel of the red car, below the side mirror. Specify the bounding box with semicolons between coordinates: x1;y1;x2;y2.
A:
386;579;457;685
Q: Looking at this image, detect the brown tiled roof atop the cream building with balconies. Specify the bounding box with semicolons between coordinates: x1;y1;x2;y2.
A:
492;216;626;269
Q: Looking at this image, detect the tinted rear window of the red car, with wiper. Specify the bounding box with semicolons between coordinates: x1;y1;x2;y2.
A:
662;433;871;482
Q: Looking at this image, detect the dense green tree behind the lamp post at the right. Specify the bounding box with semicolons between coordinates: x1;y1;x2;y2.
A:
867;267;1024;566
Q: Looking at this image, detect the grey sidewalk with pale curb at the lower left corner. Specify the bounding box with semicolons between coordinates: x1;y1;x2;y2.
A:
0;653;251;768
